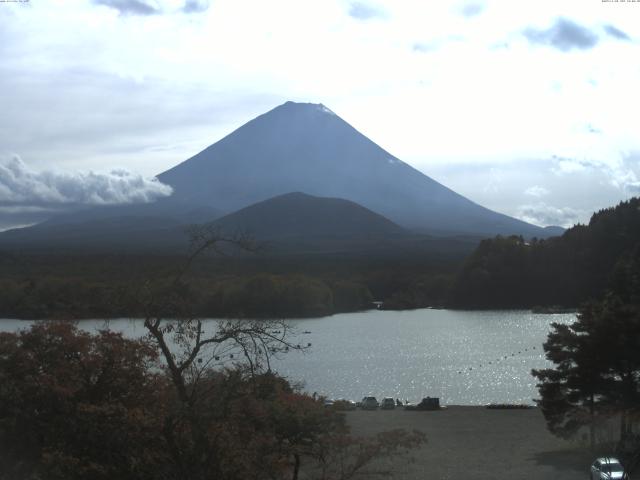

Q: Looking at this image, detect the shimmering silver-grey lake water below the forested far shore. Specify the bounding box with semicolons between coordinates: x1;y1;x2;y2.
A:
0;309;575;405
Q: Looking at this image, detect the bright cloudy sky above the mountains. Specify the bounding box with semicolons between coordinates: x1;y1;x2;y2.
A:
0;0;640;229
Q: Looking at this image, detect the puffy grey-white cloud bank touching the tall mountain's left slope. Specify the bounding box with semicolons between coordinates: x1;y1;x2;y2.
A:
0;156;172;205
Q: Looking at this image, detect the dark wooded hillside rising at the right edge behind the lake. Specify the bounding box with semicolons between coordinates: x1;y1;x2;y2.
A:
451;198;640;308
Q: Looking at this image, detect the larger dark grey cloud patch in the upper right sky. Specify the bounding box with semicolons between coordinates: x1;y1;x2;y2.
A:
524;18;599;52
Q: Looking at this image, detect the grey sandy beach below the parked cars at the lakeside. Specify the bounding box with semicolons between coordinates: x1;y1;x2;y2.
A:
347;406;637;480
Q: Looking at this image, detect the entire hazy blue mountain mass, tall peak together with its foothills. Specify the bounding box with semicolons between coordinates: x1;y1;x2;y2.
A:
0;102;560;253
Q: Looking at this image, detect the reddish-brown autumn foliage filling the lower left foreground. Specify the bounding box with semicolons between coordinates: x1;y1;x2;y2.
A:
0;322;424;480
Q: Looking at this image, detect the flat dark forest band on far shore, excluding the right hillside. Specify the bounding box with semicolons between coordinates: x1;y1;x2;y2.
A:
0;248;464;319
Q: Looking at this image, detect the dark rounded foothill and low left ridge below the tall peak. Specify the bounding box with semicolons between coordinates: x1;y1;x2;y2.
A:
0;193;408;253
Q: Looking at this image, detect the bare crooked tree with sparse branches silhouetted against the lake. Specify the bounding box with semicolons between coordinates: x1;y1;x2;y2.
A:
141;225;305;480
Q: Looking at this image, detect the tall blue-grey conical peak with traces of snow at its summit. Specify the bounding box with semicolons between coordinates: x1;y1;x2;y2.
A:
158;102;549;237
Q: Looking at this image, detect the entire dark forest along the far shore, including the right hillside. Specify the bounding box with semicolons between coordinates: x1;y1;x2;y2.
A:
5;198;640;319
